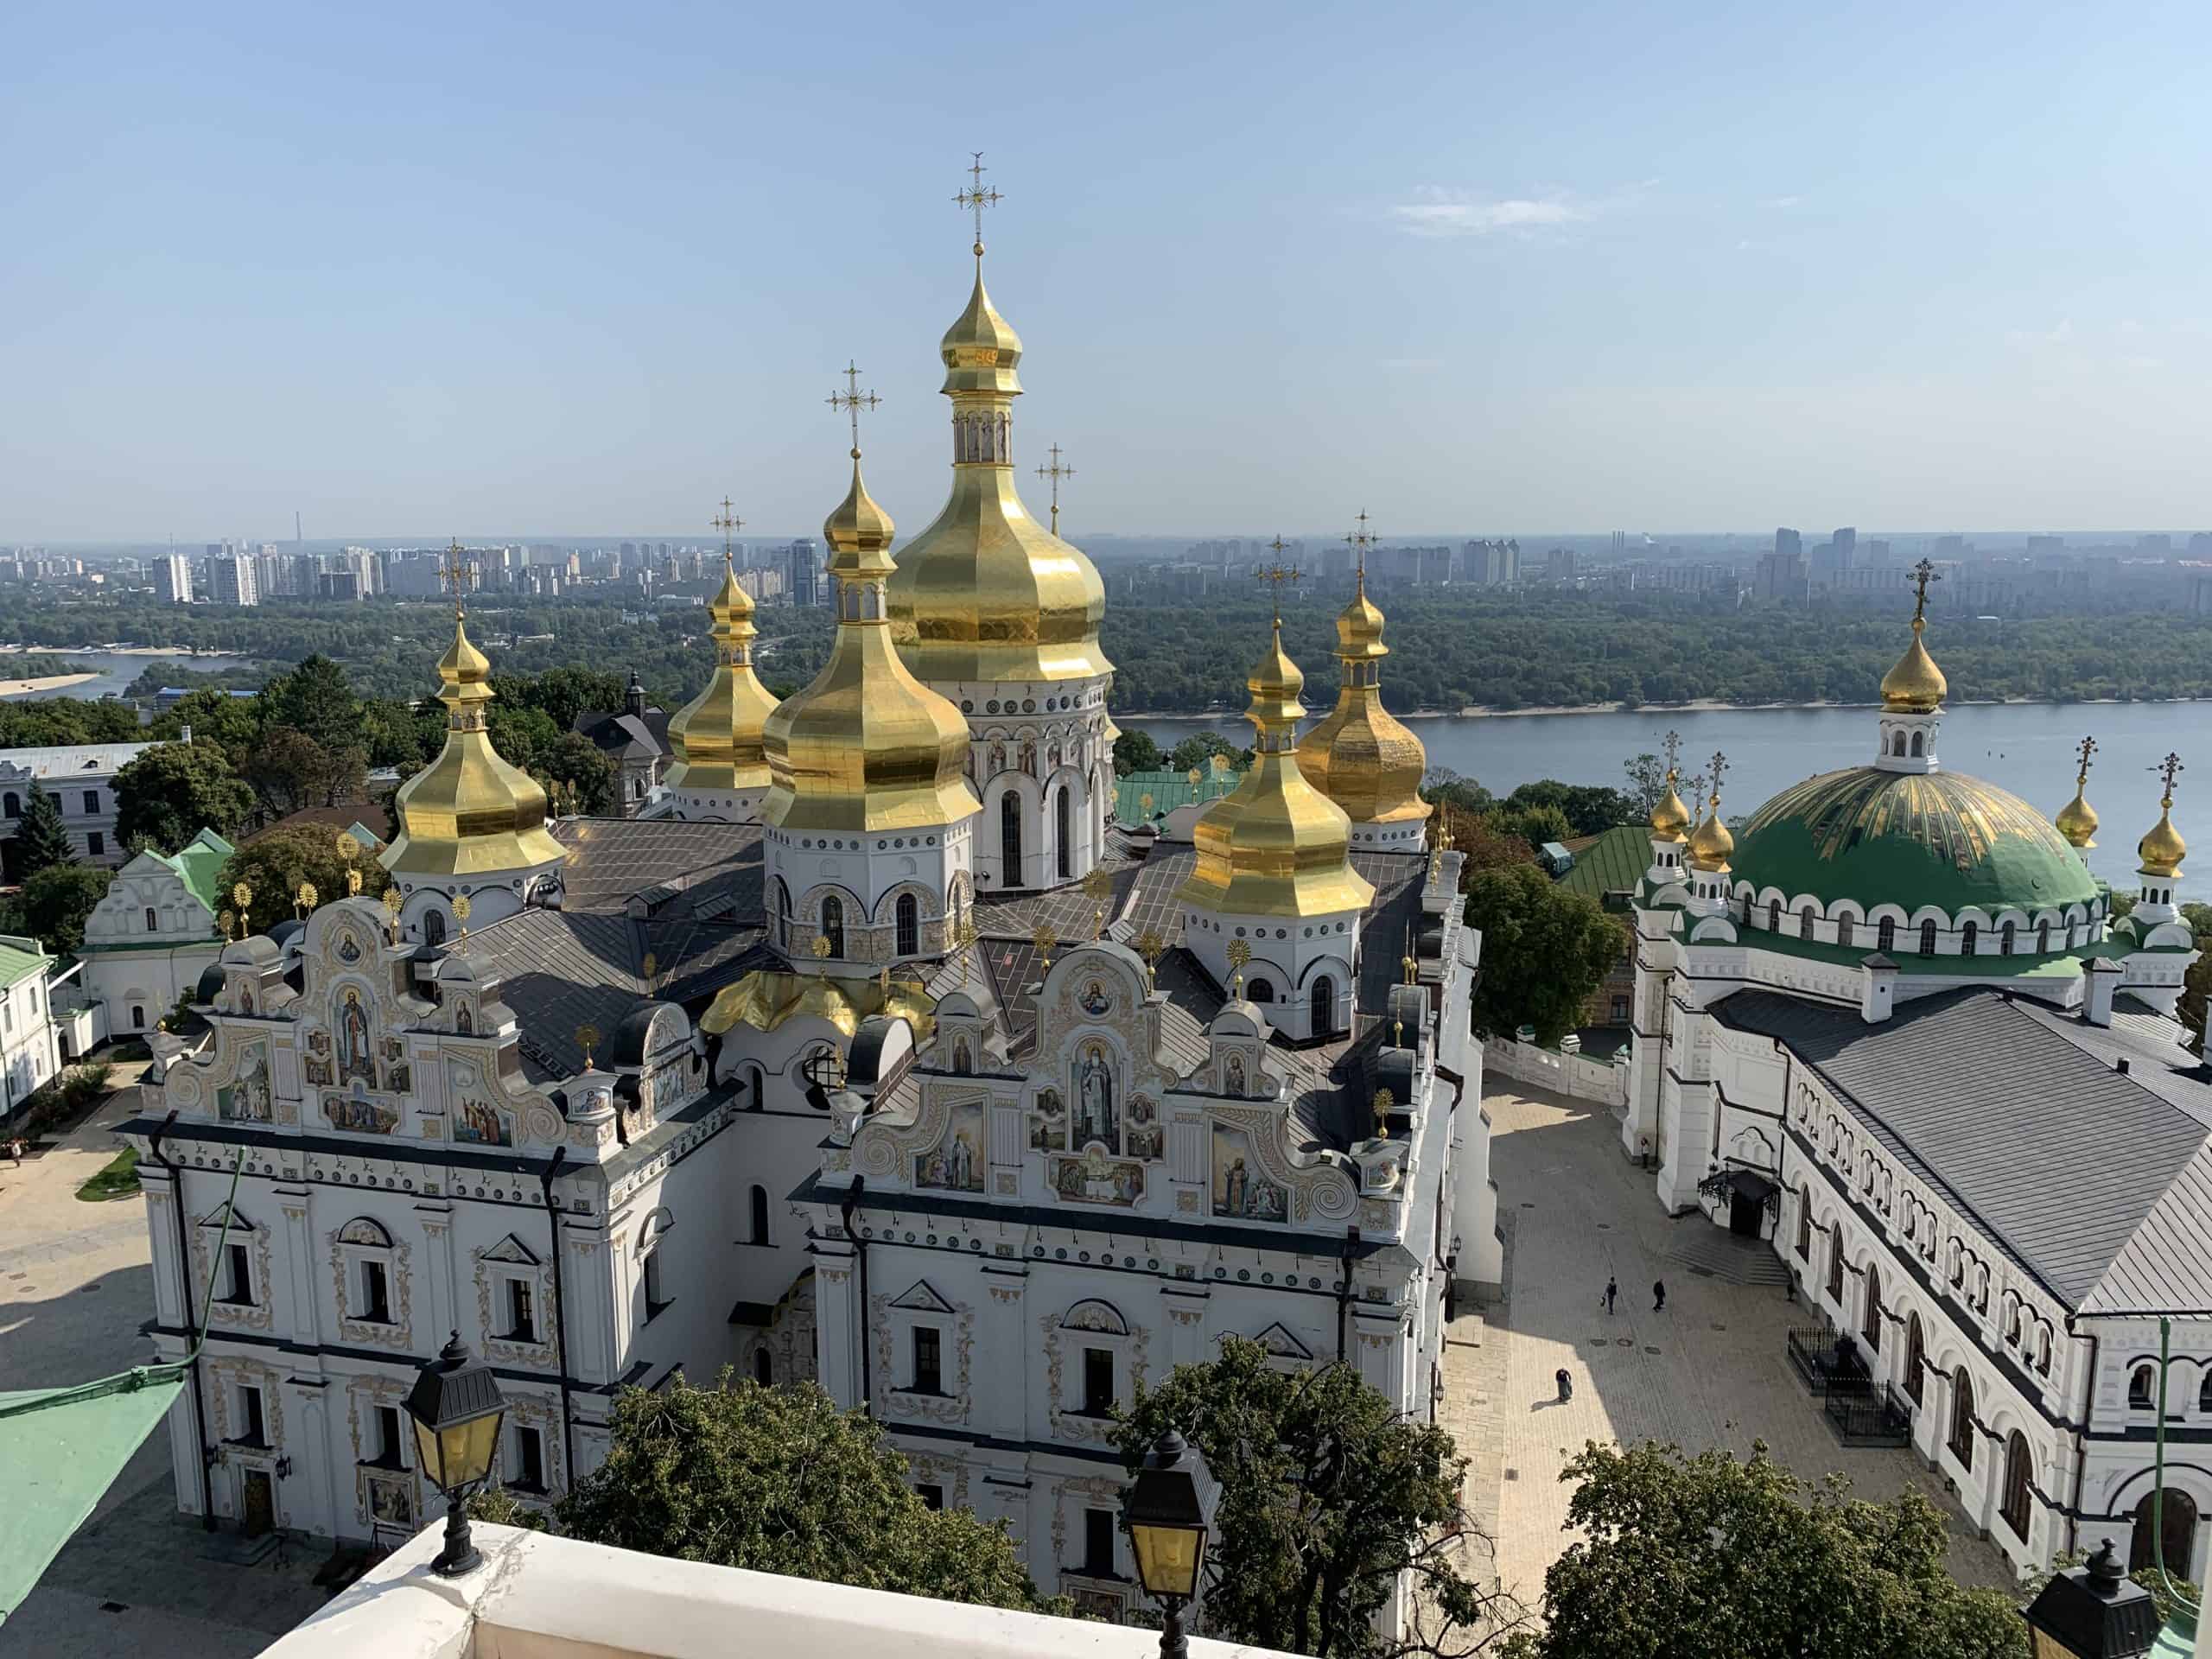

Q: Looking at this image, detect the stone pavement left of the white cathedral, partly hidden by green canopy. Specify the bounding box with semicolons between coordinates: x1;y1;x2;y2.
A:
0;1066;325;1659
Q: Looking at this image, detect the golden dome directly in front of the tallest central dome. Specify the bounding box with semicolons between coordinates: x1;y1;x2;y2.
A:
761;409;980;834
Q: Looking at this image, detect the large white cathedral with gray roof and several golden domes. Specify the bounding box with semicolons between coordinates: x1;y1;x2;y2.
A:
124;194;1500;1612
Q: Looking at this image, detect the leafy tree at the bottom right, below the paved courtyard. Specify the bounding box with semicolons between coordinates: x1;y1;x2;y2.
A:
1506;1442;2029;1659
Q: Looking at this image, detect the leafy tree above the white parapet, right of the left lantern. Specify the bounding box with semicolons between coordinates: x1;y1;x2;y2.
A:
553;1370;1066;1612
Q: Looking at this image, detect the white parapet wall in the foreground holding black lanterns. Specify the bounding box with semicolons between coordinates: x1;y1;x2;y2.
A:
261;1520;1274;1659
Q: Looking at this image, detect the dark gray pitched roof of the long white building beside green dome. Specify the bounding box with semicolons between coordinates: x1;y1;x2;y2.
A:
1714;988;2212;1307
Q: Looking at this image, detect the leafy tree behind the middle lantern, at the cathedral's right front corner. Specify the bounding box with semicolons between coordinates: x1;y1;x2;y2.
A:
1115;1336;1510;1659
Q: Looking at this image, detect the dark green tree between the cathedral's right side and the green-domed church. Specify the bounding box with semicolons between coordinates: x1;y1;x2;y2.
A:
1466;865;1628;1044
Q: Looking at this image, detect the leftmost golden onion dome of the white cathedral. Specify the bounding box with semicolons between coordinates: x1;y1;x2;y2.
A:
376;617;569;876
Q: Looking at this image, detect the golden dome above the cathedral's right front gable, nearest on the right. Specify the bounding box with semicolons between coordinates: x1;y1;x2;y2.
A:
1177;615;1374;916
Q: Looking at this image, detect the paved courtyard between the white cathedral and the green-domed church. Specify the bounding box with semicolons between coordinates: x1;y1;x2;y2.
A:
1442;1079;2013;1606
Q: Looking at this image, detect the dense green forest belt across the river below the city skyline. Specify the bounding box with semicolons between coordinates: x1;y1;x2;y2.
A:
0;588;2212;715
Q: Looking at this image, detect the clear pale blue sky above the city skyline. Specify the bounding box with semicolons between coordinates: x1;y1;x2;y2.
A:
0;0;2212;542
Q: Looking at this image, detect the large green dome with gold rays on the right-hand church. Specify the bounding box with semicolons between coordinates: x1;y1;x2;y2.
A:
1734;766;2097;916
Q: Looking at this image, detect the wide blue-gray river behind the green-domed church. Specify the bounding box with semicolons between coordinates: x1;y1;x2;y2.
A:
1122;696;2212;898
